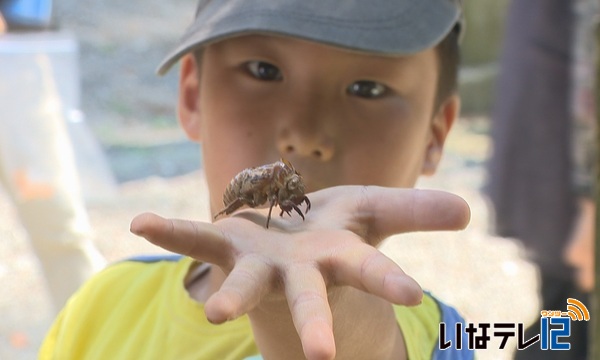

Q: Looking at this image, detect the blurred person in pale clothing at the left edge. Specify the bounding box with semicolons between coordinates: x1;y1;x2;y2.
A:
0;0;105;309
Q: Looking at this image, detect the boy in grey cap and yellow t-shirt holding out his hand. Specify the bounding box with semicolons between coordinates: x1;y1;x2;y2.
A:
41;0;472;359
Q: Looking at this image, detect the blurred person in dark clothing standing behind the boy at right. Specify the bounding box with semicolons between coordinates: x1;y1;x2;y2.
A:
486;0;596;360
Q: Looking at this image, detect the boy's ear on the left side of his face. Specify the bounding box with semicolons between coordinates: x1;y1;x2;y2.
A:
177;54;201;141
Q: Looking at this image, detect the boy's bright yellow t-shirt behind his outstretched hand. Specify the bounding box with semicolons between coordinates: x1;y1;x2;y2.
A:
39;256;441;360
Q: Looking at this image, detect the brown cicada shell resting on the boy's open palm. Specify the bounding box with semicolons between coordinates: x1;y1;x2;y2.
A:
215;159;310;228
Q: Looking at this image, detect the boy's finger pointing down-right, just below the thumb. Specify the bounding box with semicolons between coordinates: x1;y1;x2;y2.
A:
328;244;423;306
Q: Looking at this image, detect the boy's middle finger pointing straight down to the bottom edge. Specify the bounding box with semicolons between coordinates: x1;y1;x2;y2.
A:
285;266;335;359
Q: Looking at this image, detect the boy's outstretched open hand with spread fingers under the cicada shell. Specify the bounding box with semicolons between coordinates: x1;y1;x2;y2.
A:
131;186;470;358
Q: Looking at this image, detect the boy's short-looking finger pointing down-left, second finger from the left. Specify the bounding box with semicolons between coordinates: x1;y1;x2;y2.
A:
204;256;274;324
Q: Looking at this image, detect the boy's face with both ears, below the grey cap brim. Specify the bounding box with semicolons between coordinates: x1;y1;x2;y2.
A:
179;35;459;213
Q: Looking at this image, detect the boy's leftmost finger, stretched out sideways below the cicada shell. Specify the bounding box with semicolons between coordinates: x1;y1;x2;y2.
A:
130;213;231;267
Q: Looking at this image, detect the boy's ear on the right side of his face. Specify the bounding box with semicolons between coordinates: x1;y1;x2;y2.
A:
421;94;460;175
